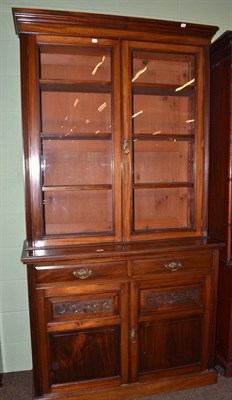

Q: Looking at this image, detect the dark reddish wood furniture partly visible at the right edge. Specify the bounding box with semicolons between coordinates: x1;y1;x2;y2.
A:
209;31;232;376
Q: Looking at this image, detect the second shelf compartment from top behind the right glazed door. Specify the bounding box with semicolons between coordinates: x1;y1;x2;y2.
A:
132;95;195;136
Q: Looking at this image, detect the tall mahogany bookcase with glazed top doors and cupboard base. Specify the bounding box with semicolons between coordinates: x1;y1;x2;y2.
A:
13;9;220;400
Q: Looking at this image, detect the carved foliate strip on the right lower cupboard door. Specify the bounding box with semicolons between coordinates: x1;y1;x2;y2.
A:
145;288;200;308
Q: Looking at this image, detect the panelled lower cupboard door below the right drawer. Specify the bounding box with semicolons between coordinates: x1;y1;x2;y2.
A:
130;275;211;382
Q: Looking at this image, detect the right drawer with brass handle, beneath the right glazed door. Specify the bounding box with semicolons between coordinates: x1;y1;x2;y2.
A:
132;252;213;277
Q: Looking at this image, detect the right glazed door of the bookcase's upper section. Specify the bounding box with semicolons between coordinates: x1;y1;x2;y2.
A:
122;41;205;240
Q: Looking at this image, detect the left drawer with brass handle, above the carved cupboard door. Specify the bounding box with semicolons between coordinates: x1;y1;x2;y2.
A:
35;261;127;284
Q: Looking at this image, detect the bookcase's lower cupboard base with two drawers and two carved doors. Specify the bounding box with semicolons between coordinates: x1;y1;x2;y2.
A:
25;246;218;399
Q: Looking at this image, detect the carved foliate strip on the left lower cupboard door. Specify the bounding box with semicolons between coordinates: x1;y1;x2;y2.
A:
53;298;114;317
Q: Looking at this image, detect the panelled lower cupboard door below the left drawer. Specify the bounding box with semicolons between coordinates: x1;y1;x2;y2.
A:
37;283;128;393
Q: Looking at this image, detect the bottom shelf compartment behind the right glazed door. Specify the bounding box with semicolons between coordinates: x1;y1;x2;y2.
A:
134;188;193;230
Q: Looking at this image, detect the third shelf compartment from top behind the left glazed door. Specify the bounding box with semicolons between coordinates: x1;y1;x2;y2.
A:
43;140;112;186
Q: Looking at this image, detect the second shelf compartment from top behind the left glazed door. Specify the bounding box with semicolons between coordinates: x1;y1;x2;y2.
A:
41;92;111;136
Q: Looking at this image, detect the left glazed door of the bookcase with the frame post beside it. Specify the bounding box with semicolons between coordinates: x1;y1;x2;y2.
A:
21;35;122;245
